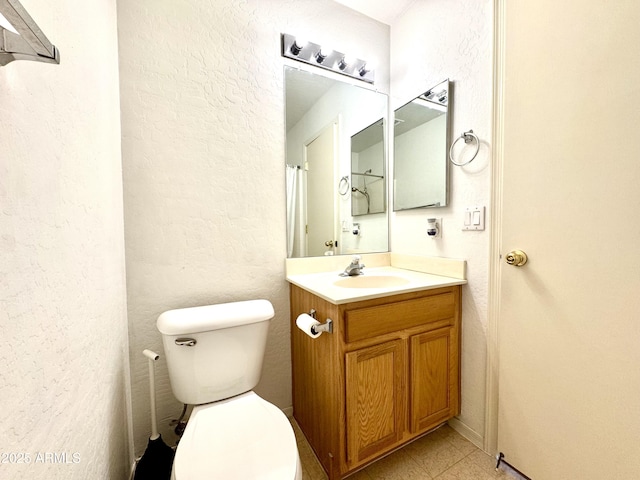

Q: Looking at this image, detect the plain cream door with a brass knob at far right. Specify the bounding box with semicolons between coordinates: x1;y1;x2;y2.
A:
496;0;640;480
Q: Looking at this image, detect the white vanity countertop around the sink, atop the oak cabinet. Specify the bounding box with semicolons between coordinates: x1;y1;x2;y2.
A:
287;266;467;305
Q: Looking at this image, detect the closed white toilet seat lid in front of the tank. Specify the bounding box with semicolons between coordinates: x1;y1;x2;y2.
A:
172;392;301;480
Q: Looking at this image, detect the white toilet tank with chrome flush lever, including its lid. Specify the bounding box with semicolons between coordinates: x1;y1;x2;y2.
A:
157;300;274;405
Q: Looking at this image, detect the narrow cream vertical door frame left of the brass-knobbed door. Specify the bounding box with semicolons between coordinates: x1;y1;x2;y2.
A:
483;0;507;455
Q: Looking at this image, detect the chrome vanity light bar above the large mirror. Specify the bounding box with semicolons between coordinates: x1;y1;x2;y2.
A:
282;32;375;84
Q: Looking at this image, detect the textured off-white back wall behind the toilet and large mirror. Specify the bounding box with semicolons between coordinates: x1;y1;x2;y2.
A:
118;0;389;452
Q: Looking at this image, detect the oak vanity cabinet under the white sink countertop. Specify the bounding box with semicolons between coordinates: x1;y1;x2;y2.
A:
290;285;460;480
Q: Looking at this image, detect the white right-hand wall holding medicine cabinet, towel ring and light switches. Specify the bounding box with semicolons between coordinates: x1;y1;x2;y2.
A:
391;0;493;444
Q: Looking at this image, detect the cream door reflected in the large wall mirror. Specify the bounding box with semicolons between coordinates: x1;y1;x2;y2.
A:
305;123;336;256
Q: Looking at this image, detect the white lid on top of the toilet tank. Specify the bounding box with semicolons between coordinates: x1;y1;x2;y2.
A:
156;300;274;335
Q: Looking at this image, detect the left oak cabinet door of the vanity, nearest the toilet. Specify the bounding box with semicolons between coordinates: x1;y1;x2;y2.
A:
344;339;407;468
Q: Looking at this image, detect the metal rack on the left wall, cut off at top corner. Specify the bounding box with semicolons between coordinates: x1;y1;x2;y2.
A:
0;0;60;66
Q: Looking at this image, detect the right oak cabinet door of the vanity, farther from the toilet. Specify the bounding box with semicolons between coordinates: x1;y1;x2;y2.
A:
410;328;459;433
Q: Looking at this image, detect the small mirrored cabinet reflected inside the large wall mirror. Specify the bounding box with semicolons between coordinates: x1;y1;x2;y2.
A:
351;118;386;217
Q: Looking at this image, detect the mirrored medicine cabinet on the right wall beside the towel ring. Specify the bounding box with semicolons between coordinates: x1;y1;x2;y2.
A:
393;80;450;211
